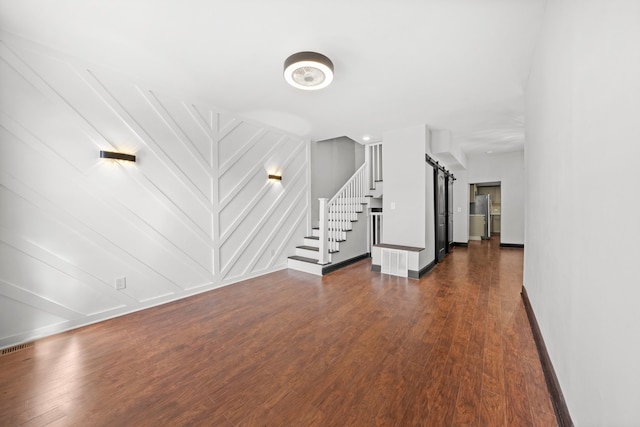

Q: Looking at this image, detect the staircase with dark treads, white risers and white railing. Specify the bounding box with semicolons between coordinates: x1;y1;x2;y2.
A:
287;144;382;276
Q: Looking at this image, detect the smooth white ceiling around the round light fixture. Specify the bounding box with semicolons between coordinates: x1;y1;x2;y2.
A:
0;0;546;157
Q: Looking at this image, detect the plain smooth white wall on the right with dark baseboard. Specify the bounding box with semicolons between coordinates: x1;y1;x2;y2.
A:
524;0;640;426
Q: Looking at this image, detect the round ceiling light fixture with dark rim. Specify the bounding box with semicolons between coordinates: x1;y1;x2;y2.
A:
284;52;333;90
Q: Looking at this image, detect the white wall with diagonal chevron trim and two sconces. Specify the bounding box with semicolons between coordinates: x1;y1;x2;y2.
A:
0;34;309;347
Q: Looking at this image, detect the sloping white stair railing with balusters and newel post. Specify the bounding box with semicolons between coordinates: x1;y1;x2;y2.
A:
318;161;368;265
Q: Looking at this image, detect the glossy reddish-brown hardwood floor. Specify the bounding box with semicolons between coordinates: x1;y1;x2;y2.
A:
0;238;556;427
